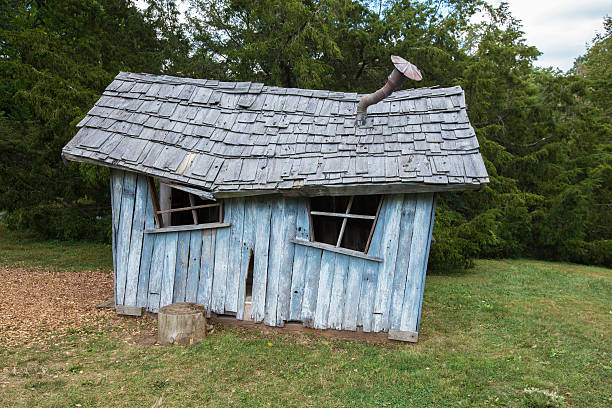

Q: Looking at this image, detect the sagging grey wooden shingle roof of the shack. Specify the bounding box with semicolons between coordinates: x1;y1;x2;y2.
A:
62;72;488;195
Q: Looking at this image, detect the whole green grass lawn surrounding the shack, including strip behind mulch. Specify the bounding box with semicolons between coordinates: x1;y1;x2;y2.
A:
0;225;612;407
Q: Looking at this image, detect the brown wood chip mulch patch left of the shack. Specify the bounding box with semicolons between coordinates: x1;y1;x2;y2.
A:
0;266;121;347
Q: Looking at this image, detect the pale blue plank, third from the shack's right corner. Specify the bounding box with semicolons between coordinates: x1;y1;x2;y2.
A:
372;194;404;332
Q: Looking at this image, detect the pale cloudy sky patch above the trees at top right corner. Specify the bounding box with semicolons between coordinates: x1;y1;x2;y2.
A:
494;0;612;71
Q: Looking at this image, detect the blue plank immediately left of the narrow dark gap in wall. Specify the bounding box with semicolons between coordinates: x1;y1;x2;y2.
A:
225;198;244;313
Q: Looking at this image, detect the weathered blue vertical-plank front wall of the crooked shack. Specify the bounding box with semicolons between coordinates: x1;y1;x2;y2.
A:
111;170;434;332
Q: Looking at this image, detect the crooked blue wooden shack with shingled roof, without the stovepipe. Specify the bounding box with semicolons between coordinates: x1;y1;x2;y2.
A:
63;73;488;341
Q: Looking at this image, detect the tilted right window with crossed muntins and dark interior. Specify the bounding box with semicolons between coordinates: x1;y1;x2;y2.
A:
310;195;382;253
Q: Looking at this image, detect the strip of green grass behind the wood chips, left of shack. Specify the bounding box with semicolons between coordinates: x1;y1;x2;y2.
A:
0;222;113;271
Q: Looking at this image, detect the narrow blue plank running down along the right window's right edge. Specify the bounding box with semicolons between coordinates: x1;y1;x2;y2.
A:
357;196;391;332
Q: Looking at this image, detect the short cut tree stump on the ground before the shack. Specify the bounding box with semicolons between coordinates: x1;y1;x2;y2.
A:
157;303;206;345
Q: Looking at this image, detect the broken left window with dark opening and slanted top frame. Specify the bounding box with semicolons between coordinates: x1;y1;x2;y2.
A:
149;178;223;228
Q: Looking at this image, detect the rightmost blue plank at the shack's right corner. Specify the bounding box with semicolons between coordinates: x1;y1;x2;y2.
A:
400;194;433;332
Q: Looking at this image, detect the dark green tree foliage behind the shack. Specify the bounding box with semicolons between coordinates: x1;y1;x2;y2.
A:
0;0;612;270
